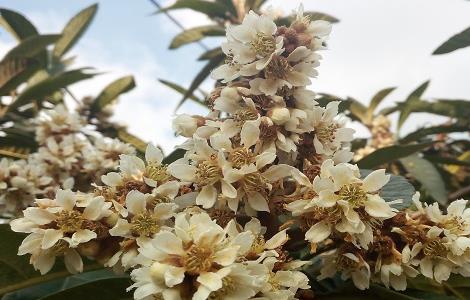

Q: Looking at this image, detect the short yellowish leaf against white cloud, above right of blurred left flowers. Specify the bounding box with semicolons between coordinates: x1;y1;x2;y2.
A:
91;76;135;112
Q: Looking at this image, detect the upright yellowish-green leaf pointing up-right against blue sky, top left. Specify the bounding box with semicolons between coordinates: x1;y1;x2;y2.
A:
52;4;98;57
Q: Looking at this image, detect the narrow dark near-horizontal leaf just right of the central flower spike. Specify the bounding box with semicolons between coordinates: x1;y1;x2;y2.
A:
357;143;433;169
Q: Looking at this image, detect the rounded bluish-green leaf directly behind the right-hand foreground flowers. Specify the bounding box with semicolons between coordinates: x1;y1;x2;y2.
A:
361;169;416;210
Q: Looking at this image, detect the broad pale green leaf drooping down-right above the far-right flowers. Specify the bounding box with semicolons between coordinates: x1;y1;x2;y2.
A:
400;155;447;205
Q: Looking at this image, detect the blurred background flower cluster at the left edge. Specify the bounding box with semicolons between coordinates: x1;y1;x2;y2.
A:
0;105;135;217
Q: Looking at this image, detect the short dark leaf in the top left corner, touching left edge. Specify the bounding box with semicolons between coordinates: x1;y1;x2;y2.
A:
0;8;39;41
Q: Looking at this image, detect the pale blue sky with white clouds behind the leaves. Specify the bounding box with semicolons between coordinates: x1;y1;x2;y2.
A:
0;0;470;153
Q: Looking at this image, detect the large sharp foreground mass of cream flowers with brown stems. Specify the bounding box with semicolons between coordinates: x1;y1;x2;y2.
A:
8;5;470;300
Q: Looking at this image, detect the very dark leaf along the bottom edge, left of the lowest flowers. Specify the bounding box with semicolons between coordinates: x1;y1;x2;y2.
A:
39;278;132;300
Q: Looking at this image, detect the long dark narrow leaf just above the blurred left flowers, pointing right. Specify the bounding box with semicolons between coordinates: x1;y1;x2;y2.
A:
8;69;96;111
